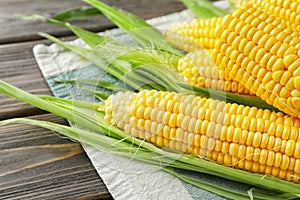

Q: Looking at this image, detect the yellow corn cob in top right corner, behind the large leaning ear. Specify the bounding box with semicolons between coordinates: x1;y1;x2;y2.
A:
243;0;300;31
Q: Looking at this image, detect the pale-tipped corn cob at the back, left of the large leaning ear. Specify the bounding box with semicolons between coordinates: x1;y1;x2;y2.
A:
164;18;222;52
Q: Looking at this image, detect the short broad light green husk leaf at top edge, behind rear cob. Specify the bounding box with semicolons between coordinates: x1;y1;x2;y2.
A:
181;0;229;19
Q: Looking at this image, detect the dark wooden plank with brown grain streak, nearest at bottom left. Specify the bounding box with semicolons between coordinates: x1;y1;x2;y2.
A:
0;114;112;199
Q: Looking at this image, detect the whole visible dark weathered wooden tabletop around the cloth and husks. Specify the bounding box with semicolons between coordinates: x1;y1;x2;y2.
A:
0;0;188;199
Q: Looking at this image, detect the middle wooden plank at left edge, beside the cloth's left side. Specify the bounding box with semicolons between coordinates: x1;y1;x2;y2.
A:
0;41;51;119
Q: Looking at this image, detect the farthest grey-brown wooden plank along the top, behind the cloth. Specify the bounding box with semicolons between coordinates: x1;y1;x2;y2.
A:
0;0;184;44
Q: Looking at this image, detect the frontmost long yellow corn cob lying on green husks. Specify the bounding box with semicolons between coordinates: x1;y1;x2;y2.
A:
105;90;300;182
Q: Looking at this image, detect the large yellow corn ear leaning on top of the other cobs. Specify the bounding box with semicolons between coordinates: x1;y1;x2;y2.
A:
211;4;300;118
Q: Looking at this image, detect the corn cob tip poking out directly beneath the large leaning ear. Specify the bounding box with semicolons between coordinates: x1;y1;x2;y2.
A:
177;49;253;95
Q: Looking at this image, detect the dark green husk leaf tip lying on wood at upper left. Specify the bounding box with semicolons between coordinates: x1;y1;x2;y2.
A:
52;6;102;21
